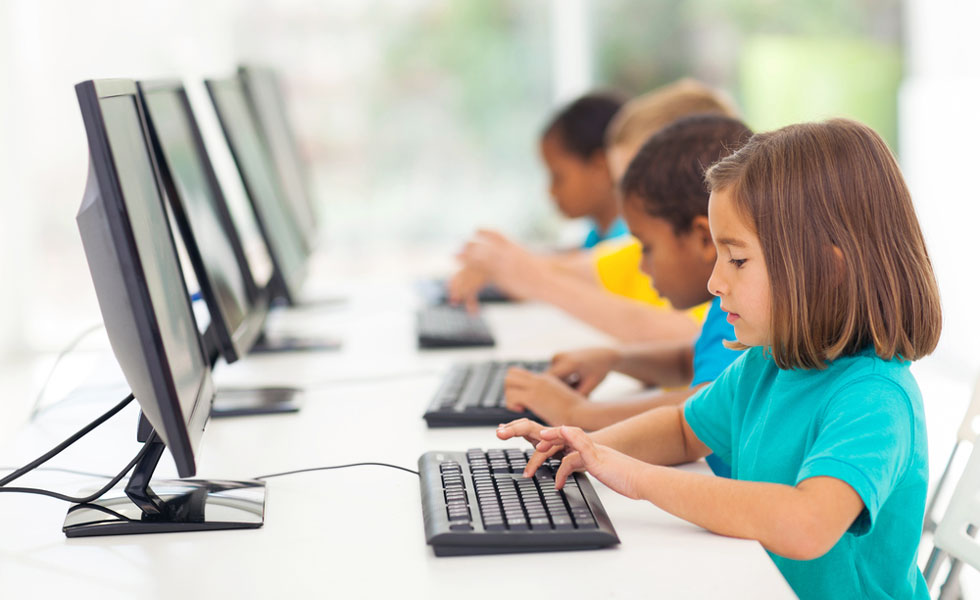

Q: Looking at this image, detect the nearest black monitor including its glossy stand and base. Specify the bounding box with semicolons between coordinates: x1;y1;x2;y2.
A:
64;80;265;537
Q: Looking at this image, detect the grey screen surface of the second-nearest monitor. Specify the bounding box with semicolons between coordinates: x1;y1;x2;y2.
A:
143;87;258;360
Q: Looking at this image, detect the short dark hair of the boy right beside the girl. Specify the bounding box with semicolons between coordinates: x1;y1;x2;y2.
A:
620;115;752;233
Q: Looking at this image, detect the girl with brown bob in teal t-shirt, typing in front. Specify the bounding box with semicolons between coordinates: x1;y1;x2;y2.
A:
497;120;942;598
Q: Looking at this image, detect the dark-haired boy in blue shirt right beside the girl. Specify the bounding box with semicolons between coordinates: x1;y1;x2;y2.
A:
505;115;752;454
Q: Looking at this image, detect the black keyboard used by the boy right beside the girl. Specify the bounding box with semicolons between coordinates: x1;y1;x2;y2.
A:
422;361;548;427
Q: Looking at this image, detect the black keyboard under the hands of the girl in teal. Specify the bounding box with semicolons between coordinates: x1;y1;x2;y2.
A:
419;448;619;556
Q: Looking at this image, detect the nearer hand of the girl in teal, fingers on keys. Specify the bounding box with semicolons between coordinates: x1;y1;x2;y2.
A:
536;426;647;500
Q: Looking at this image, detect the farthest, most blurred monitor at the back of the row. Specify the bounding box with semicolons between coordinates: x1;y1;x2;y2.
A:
238;65;319;247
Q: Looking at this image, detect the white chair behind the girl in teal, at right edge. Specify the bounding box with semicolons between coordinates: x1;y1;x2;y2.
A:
922;378;980;599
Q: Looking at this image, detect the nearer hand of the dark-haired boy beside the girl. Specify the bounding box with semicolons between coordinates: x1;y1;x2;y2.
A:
504;367;588;425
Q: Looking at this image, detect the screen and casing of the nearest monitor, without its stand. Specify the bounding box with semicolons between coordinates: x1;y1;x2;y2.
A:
76;80;214;477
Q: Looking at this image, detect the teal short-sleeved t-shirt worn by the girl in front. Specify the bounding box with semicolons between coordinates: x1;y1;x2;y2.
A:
684;348;929;598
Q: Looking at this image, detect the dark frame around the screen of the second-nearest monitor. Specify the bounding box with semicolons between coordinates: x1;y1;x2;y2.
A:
136;79;269;363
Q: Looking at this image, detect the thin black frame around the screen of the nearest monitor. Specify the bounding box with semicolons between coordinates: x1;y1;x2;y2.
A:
75;79;215;477
